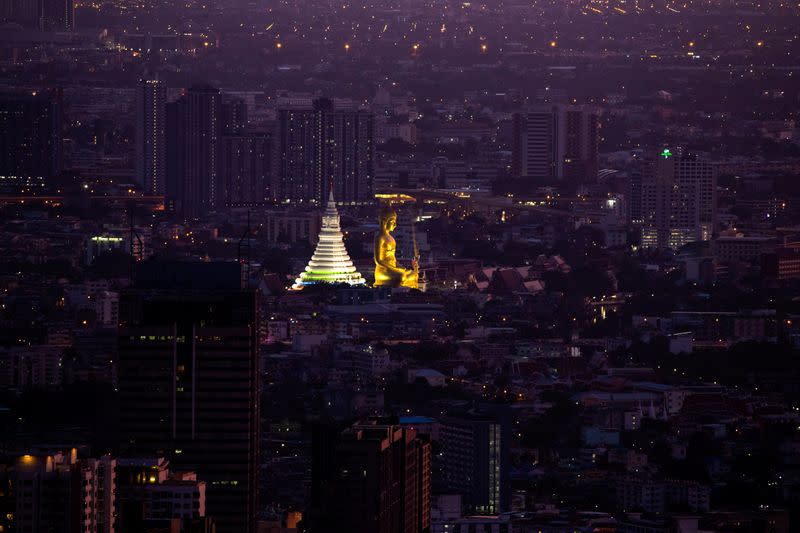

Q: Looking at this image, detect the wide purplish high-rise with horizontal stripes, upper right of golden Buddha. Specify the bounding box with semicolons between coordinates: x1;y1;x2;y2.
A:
512;105;599;185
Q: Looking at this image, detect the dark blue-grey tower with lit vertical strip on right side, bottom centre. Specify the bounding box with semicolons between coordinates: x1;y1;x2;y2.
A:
436;411;509;514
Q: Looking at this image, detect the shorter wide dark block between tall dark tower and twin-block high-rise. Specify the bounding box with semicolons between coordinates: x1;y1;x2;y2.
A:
220;133;272;207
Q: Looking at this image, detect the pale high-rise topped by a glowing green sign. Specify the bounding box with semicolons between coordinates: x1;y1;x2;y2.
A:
641;148;717;249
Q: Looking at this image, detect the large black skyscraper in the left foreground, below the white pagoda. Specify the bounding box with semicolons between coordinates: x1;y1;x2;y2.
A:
118;263;259;533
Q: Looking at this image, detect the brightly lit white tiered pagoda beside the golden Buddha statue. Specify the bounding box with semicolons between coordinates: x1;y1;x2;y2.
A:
292;191;366;290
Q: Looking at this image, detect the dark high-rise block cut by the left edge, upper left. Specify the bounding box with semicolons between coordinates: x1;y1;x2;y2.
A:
0;94;61;189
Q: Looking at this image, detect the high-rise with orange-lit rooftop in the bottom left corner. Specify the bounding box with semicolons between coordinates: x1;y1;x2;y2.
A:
10;448;116;533
